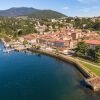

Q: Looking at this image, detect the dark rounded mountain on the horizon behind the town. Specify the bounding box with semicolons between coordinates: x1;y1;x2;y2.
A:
0;7;66;18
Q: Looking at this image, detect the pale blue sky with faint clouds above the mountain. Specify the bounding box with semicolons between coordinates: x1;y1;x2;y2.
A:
0;0;100;17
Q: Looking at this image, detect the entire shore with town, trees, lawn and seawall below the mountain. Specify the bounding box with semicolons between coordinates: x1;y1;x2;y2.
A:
0;7;100;93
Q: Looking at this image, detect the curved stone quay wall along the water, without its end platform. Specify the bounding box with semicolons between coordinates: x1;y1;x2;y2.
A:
30;49;95;78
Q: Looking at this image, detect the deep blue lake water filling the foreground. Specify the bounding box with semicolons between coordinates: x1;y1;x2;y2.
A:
0;43;100;100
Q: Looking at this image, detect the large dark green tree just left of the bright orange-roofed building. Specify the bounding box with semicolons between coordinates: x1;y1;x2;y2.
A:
75;42;88;57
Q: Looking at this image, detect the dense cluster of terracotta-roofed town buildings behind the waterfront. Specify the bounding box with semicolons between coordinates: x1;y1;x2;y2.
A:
4;27;100;52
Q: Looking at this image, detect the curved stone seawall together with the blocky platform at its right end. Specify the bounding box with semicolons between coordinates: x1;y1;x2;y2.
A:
30;49;100;92
